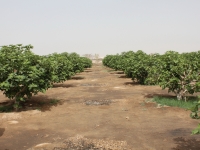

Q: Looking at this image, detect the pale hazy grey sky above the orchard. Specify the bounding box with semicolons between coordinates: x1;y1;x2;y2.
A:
0;0;200;56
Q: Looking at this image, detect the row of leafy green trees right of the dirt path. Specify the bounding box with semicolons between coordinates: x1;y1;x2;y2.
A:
103;50;200;100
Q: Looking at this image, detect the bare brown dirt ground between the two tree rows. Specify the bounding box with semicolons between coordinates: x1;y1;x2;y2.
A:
0;64;200;150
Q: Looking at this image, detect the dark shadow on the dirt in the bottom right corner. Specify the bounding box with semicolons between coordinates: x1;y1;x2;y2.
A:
172;137;200;150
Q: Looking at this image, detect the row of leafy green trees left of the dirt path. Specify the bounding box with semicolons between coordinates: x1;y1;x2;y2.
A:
0;44;92;109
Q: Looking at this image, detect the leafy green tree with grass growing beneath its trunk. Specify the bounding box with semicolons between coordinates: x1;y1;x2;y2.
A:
146;51;200;101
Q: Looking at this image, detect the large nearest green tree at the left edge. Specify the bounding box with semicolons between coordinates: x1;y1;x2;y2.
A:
0;44;51;109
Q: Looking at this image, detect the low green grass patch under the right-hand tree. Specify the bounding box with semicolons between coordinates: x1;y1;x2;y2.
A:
152;96;199;109
